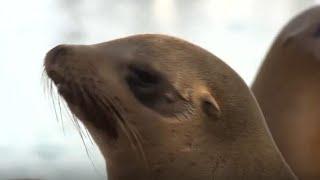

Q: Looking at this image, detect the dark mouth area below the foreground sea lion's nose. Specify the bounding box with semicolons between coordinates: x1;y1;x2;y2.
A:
46;70;118;138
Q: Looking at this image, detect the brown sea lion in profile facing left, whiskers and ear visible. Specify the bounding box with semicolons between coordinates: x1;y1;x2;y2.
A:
44;34;295;180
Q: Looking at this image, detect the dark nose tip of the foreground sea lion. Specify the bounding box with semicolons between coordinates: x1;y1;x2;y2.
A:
45;44;70;65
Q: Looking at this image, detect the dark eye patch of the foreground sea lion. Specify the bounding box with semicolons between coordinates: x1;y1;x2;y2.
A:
126;64;186;116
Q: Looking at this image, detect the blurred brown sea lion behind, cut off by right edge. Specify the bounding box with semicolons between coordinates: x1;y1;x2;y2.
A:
252;6;320;179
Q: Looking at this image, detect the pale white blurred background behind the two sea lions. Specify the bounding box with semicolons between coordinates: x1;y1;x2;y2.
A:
0;0;320;180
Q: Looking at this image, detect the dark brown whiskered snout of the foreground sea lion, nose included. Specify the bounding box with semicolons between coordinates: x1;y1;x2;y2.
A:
44;44;118;139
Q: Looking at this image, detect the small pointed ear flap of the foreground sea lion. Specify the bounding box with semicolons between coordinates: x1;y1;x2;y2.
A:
200;93;221;118
